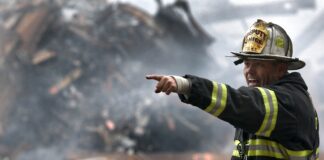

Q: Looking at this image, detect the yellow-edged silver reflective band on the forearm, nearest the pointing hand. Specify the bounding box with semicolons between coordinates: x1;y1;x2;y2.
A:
205;82;227;116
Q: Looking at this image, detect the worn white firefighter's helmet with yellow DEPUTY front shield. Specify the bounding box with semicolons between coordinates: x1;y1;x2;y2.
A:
232;19;305;70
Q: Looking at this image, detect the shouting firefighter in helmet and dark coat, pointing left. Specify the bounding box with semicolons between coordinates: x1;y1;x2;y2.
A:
146;20;319;160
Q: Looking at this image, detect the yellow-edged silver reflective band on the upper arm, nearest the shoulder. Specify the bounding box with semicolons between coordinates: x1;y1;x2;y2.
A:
255;87;278;137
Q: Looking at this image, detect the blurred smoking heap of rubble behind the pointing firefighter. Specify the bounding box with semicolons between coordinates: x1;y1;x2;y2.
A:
0;1;230;159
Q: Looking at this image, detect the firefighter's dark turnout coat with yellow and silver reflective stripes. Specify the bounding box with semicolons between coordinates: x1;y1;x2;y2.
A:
179;72;319;160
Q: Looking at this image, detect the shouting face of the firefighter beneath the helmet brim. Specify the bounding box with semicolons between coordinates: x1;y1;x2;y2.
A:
243;59;287;87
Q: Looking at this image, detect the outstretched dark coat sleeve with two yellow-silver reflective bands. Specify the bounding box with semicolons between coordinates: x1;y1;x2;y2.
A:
179;75;297;137
